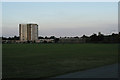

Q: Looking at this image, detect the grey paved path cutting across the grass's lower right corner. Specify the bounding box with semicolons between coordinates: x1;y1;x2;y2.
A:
52;64;118;78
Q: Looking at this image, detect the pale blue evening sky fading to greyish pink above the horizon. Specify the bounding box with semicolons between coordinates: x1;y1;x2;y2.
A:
2;2;118;37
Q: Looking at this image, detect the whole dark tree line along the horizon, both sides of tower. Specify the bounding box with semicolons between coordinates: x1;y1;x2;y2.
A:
2;32;120;43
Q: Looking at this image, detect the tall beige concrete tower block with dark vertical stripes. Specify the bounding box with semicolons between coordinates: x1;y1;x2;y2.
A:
19;24;38;41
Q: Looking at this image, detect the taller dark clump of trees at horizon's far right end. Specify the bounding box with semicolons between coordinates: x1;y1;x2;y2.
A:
81;32;120;43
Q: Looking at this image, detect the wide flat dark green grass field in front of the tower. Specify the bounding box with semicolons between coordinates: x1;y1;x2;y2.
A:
2;44;118;78
